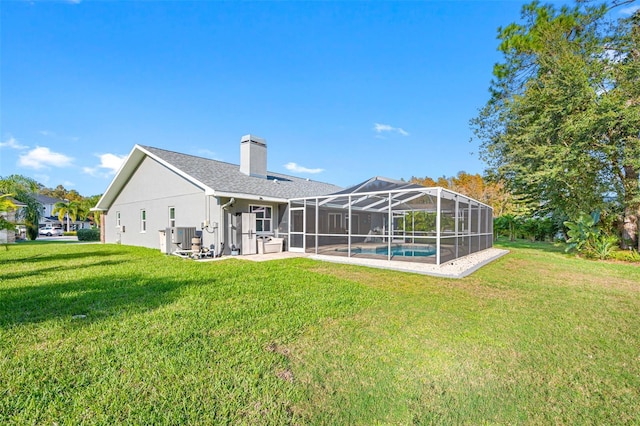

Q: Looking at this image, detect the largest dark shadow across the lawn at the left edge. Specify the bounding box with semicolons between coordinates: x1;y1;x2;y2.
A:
0;270;211;327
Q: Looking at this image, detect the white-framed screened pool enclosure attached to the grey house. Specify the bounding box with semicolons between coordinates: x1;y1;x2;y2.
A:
289;177;493;265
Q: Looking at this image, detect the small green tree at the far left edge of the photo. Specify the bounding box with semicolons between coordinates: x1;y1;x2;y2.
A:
0;175;42;240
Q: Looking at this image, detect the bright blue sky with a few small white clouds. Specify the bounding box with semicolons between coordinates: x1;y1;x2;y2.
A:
0;0;608;196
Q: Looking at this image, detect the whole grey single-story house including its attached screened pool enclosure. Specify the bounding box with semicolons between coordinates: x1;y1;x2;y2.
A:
94;135;493;265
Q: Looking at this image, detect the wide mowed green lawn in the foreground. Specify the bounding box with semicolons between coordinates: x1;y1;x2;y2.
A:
0;243;640;425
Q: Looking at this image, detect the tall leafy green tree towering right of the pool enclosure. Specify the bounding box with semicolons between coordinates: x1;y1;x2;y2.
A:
471;2;640;250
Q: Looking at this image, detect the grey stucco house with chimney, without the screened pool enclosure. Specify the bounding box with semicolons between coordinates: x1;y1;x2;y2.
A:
94;135;342;254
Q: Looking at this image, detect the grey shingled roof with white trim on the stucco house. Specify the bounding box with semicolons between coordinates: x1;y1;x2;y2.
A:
96;145;342;210
